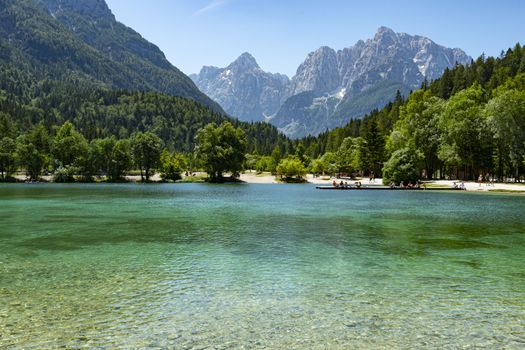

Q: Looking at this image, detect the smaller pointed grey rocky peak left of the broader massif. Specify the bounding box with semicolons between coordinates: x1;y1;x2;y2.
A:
190;53;290;121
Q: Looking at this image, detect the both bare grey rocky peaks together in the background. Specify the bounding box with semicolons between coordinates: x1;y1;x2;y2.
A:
190;27;472;138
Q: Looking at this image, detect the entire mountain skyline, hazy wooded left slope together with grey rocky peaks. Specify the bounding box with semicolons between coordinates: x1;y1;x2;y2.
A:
0;0;471;138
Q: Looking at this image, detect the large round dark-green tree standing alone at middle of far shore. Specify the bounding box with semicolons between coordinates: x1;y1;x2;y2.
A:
196;122;246;181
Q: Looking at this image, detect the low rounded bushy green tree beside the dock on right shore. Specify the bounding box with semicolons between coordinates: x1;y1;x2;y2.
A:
383;145;423;185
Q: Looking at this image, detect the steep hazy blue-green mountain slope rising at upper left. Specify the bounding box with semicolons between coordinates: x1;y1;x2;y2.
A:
0;0;222;111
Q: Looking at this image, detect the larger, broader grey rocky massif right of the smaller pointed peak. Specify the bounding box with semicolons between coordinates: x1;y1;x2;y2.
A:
271;27;471;138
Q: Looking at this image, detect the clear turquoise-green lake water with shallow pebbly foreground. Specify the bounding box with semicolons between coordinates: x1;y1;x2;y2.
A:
0;184;525;349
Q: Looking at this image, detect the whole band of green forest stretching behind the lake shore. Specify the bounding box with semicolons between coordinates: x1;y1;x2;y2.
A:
0;44;525;183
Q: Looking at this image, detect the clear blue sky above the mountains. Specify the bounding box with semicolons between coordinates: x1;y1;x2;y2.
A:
106;0;525;76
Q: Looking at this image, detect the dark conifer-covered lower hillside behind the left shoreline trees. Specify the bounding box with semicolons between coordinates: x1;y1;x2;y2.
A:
0;67;287;154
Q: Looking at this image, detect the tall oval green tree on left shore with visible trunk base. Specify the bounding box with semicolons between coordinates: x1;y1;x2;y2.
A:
130;131;163;181
